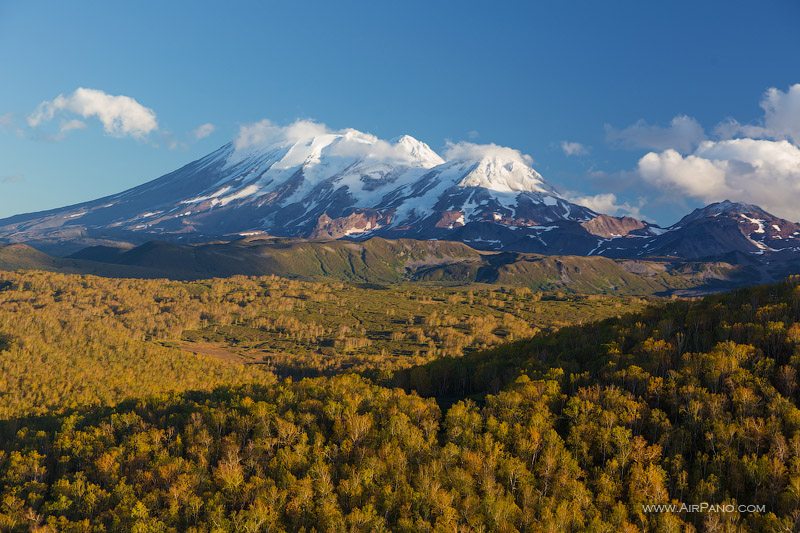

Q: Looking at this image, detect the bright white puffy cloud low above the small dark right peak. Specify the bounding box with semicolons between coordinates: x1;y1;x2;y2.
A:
638;139;800;220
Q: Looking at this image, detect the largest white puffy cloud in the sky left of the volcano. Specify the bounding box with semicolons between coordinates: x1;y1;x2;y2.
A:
28;87;158;138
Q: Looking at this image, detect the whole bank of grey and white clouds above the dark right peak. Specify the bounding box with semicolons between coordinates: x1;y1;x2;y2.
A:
606;80;800;220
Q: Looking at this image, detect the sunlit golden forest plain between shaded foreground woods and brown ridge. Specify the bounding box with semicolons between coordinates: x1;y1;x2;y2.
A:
0;271;645;419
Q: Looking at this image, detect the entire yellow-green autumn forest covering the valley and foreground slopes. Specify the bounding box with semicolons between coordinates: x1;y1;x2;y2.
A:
0;272;800;532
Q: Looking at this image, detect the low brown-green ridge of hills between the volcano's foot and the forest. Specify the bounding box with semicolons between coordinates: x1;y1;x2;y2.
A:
0;237;756;295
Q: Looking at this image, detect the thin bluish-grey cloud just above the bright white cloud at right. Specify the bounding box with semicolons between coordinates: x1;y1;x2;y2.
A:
606;115;706;153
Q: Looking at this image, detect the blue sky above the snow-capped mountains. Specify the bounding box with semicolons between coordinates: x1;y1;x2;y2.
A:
0;0;800;224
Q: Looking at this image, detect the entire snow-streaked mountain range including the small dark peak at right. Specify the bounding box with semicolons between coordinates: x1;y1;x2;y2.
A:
0;121;800;264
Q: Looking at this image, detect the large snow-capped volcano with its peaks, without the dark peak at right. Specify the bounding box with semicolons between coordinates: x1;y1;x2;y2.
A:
0;121;596;247
